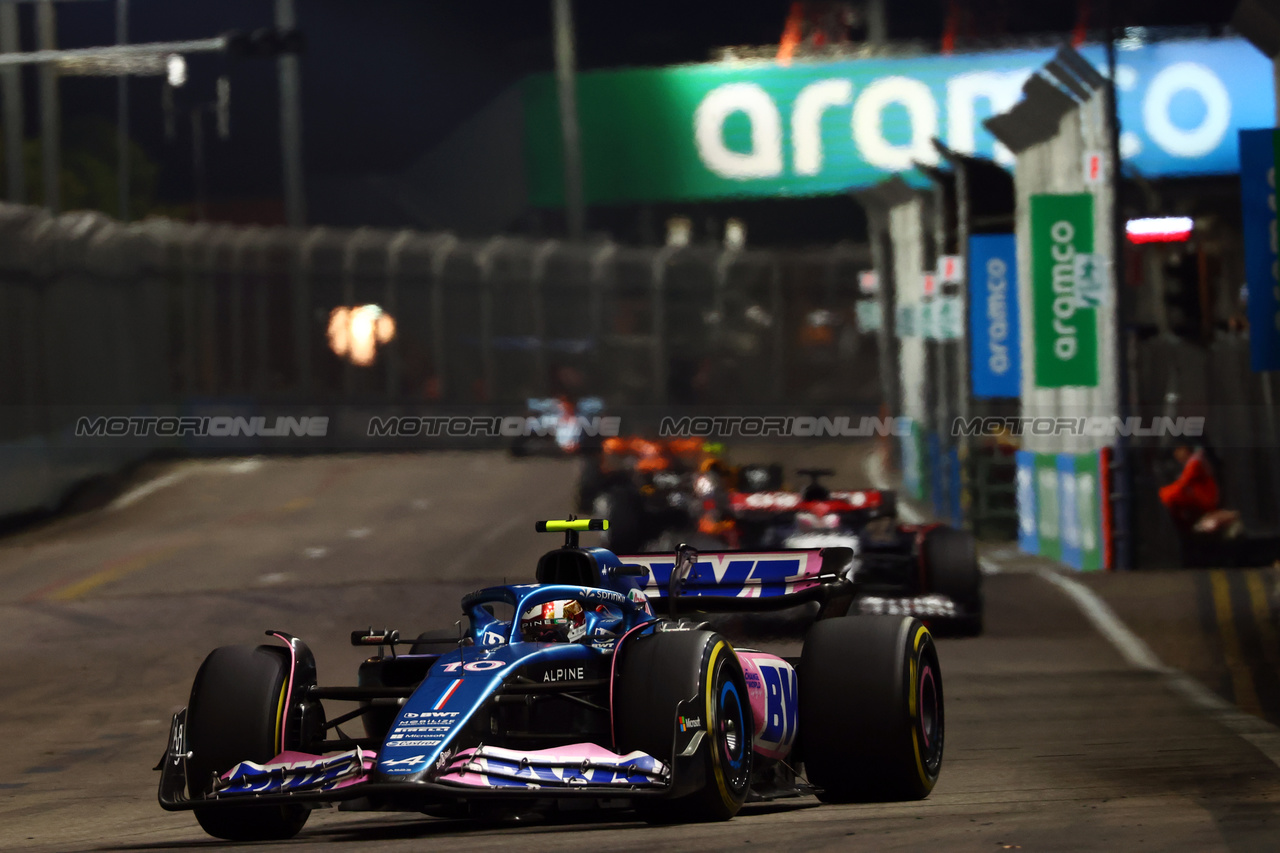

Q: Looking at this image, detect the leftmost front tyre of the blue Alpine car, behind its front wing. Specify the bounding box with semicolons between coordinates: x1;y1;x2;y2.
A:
187;646;311;841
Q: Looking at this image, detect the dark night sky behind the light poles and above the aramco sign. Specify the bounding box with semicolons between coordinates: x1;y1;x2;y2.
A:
24;0;1234;208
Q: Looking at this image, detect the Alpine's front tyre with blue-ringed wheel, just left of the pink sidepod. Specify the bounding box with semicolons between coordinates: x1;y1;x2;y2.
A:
613;630;755;824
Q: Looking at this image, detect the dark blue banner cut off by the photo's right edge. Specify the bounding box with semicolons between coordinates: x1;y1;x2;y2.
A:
1240;129;1280;370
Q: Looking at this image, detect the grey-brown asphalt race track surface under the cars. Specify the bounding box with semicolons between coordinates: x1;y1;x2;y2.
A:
0;452;1280;852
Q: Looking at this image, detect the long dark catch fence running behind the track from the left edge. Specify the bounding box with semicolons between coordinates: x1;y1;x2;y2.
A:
0;205;881;515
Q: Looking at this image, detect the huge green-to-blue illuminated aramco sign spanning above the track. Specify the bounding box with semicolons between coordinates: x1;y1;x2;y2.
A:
525;38;1275;205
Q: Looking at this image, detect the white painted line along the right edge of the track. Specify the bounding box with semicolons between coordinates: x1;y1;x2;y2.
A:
867;440;1280;767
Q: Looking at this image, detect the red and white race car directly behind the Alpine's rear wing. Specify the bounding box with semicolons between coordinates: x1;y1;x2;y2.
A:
699;469;983;635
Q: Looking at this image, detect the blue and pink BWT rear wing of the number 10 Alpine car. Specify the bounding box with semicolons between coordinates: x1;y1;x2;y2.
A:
618;546;854;619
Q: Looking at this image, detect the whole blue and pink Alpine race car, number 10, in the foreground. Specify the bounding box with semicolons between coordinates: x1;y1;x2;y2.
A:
157;520;945;840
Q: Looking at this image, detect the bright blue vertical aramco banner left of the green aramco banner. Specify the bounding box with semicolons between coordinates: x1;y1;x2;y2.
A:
968;234;1023;400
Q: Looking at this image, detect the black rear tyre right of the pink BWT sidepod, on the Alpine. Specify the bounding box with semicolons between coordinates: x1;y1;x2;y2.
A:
797;615;945;803
